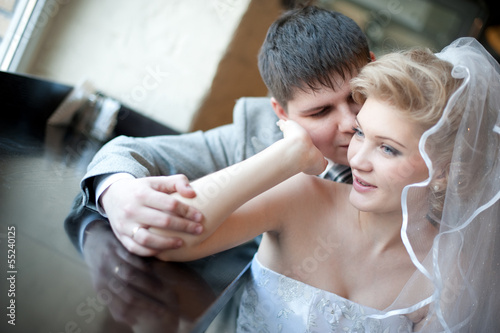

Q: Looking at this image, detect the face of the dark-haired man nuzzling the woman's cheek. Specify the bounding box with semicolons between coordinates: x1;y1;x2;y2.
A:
272;77;361;165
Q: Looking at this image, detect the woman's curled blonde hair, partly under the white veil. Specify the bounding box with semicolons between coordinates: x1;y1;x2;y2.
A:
351;48;463;220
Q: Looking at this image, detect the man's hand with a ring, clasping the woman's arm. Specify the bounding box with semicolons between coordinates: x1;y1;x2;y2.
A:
100;175;203;256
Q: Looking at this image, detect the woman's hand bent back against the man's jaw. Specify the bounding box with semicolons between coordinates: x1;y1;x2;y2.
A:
277;119;328;175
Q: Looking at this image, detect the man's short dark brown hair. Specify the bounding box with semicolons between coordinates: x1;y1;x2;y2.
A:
259;6;371;109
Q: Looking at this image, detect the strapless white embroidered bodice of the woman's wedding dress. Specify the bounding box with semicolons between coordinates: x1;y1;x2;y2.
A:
237;255;413;333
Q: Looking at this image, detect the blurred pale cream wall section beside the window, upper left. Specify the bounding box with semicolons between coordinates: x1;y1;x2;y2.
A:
26;0;250;131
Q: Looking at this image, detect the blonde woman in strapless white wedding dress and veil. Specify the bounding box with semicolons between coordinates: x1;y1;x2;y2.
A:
150;39;500;332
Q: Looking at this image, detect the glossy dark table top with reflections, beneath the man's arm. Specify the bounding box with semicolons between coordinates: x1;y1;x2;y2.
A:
0;71;256;333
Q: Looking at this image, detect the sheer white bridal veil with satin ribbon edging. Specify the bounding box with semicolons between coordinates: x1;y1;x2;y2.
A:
374;38;500;332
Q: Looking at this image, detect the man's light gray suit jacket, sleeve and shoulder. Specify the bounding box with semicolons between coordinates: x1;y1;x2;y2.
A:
81;97;283;209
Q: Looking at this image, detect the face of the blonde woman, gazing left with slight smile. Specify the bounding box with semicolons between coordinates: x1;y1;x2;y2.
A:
348;98;428;213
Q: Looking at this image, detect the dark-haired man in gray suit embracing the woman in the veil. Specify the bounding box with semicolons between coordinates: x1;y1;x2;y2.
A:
81;6;374;256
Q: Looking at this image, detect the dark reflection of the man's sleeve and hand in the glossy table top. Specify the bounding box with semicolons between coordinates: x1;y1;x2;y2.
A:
65;198;255;332
